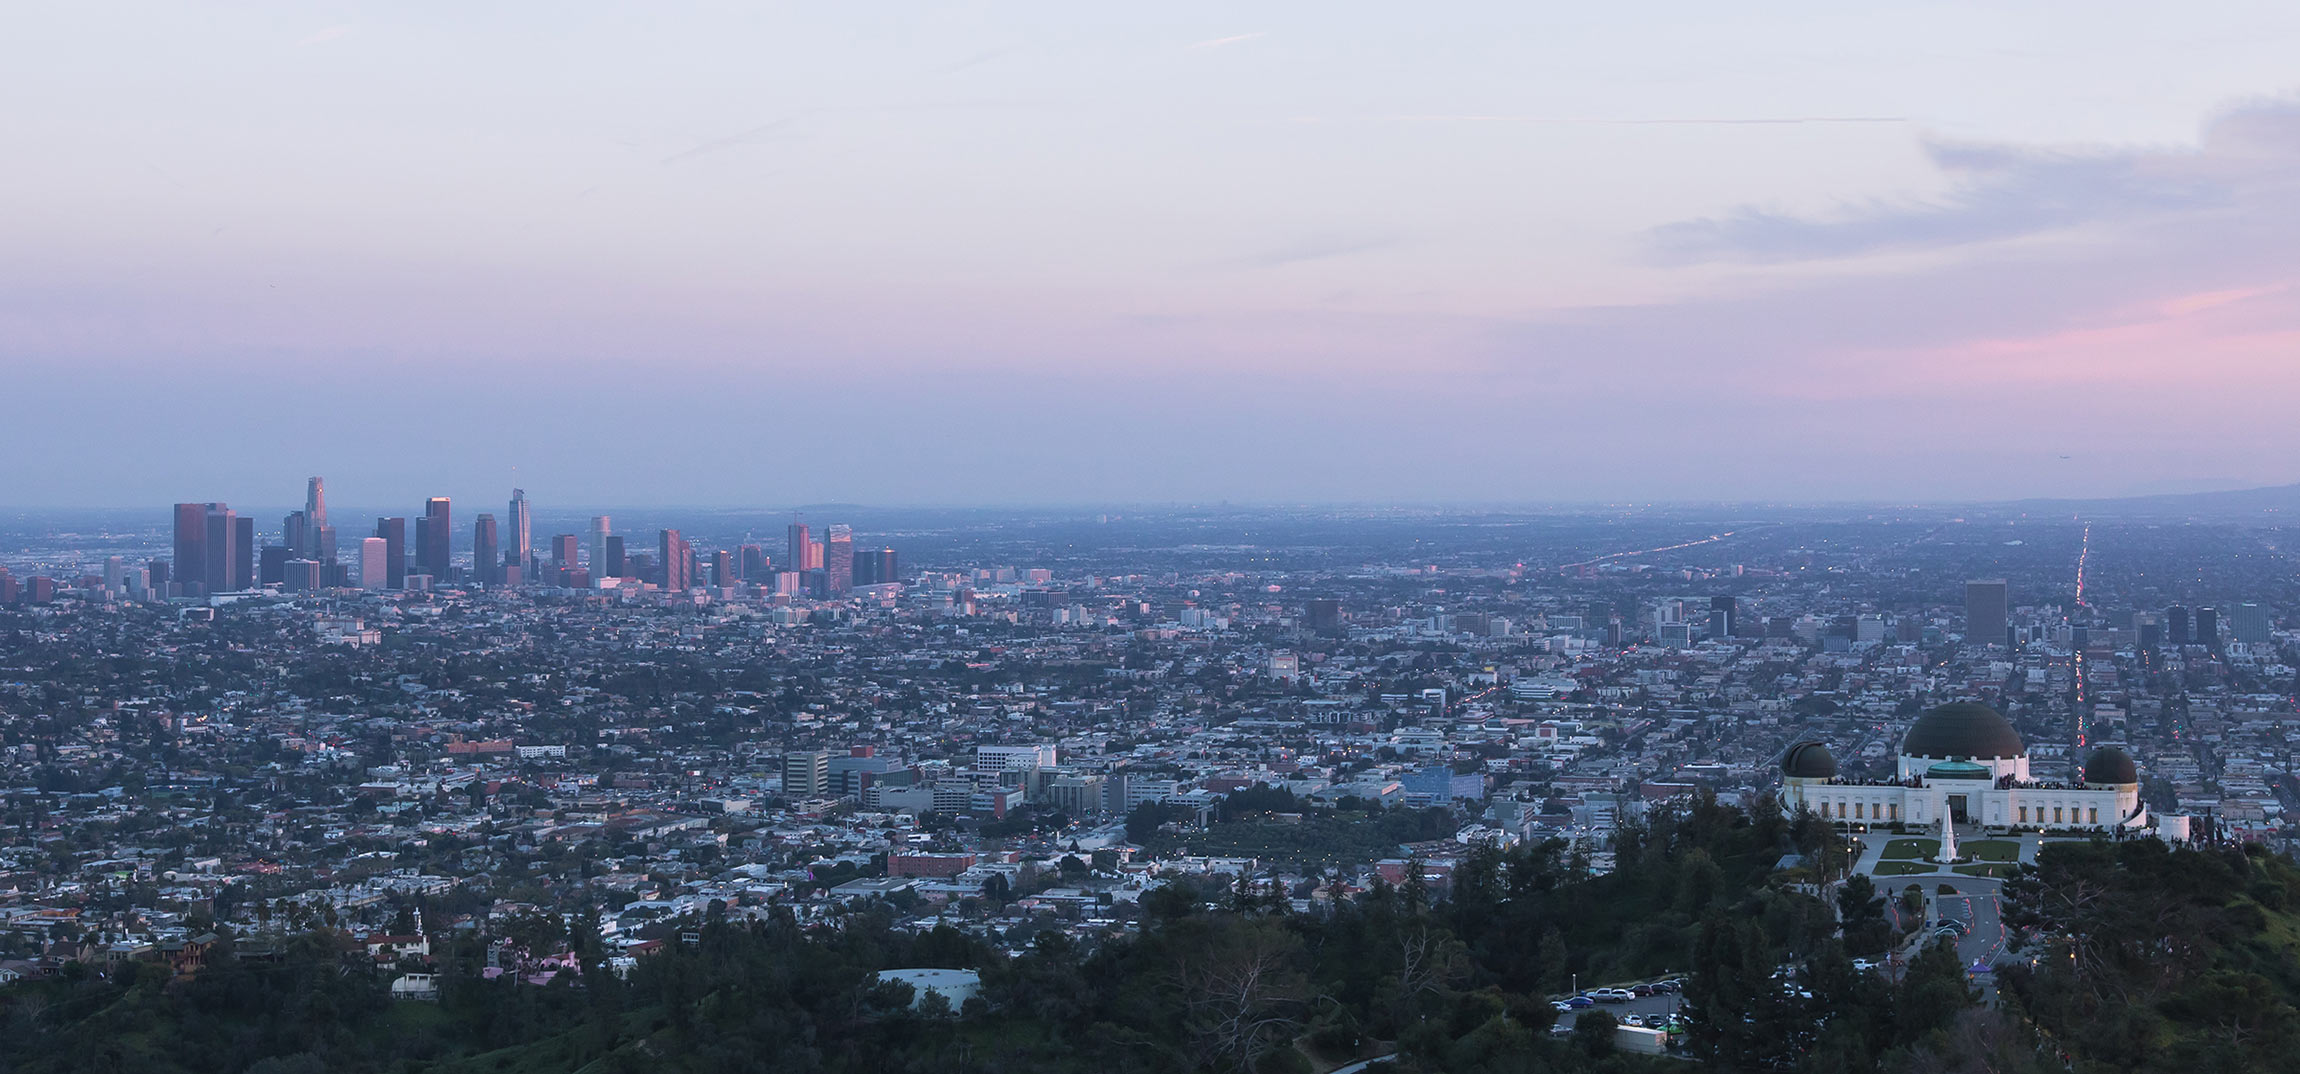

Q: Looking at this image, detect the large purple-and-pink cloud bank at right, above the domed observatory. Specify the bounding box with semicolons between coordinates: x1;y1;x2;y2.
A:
1493;101;2300;439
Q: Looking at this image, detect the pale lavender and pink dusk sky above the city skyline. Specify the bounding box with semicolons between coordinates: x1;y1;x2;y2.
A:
0;0;2300;506
